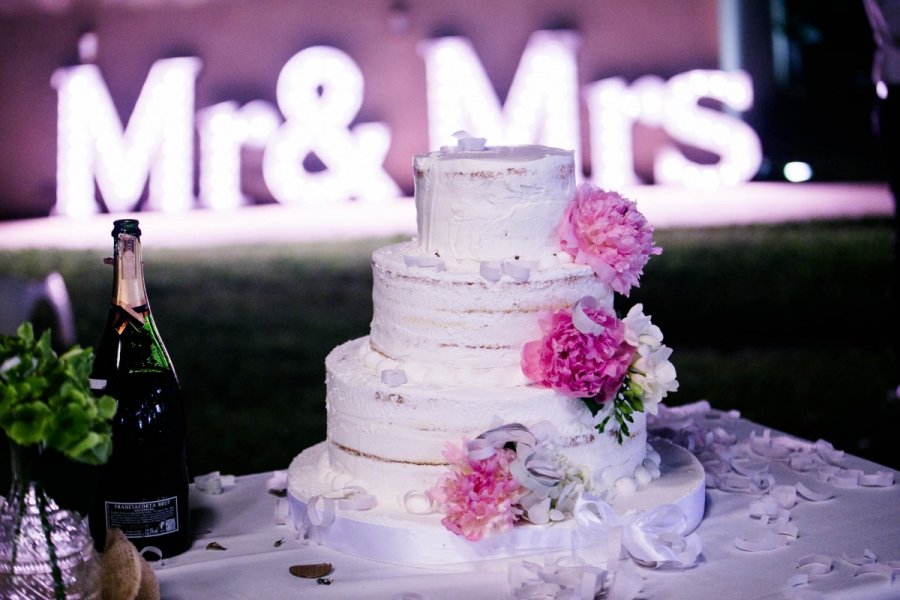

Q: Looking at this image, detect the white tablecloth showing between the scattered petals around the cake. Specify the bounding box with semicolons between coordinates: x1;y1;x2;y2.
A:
154;411;900;600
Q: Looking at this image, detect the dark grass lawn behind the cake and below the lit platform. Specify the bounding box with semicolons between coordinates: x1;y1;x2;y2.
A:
0;220;900;490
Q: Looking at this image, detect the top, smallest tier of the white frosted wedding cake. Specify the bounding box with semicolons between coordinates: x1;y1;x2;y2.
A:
413;146;575;261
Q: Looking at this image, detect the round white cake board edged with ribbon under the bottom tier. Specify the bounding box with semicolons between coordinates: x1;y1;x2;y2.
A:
288;439;706;567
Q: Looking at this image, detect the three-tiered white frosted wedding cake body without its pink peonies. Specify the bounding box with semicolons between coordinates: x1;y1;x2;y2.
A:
289;138;660;516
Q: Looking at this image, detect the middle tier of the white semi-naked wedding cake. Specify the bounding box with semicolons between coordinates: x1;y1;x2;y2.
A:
364;242;613;385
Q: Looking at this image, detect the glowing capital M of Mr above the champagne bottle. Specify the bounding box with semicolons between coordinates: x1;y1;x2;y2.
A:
51;57;201;216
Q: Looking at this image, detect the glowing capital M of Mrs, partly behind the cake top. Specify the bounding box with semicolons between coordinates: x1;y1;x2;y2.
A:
419;31;581;168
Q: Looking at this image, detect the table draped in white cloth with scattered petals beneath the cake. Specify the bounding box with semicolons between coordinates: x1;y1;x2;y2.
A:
154;403;900;600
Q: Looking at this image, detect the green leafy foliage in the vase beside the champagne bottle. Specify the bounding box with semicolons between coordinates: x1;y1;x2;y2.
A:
0;322;117;465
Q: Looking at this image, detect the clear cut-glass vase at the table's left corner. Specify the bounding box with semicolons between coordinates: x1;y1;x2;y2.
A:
0;443;100;600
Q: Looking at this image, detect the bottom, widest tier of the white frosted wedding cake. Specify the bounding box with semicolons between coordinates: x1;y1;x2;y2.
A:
321;338;647;510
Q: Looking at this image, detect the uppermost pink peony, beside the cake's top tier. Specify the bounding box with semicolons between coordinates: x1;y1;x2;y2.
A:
558;183;662;296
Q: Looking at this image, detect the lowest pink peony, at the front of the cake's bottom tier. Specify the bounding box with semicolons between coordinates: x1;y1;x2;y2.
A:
426;443;524;542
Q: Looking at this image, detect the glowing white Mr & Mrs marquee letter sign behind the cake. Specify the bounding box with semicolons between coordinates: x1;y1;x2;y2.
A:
51;31;762;215
